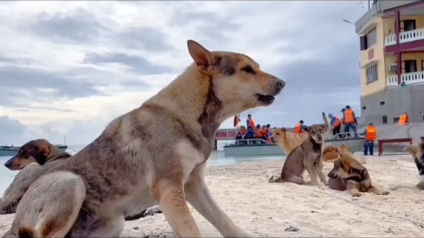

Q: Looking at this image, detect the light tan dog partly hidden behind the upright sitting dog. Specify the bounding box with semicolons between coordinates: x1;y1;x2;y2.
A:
272;127;309;155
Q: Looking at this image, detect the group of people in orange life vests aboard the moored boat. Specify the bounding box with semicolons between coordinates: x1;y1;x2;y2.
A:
236;114;272;143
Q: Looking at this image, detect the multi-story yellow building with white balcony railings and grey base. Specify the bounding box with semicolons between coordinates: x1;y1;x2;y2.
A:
355;0;424;125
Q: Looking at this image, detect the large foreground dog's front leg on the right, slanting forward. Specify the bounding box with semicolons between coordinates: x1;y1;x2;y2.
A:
185;169;251;237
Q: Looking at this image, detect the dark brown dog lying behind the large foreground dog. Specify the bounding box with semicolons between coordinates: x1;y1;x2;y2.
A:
0;139;160;221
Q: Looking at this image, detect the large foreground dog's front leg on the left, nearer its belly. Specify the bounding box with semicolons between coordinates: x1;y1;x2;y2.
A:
152;178;200;237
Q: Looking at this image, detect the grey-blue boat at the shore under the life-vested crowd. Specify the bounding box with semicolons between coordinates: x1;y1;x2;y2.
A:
224;139;285;157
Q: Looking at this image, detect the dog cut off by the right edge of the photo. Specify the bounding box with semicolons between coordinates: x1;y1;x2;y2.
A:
390;143;424;190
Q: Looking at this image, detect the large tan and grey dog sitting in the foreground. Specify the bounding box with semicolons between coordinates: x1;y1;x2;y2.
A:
6;40;285;237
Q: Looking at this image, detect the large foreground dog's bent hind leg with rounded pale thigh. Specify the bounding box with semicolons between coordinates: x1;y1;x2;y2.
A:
11;172;86;237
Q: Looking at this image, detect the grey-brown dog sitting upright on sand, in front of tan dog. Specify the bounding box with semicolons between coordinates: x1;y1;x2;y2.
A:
269;112;330;185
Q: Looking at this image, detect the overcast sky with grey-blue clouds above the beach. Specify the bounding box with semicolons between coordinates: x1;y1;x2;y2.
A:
0;1;366;145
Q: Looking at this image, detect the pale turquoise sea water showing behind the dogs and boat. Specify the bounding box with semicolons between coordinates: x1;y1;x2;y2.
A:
0;142;283;193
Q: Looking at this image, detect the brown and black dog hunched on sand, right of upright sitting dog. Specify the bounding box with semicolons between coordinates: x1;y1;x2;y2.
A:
328;155;389;197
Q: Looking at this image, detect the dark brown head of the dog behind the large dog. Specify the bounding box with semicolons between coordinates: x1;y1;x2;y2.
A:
4;139;71;170
